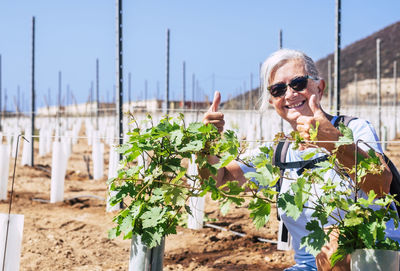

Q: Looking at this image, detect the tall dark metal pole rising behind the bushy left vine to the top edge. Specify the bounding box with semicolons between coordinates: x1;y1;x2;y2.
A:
116;0;124;149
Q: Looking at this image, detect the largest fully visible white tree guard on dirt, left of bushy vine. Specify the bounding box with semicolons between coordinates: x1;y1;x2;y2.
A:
50;141;67;203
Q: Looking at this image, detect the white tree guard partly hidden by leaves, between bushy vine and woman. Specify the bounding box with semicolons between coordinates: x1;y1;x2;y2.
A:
187;155;205;230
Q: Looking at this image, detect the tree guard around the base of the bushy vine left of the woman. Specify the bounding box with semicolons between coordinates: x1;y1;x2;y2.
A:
128;235;165;271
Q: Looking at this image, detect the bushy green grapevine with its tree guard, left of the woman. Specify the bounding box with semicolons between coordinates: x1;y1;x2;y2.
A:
108;115;279;270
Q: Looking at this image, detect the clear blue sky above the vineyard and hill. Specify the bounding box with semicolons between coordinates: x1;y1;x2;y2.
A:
0;0;400;111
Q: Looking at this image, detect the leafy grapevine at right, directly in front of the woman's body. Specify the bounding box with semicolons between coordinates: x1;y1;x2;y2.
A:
278;124;400;270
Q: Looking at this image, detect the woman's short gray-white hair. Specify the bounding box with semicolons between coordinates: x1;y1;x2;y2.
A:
259;49;320;111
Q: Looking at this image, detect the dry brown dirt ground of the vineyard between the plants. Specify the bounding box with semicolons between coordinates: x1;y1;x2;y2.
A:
0;128;400;271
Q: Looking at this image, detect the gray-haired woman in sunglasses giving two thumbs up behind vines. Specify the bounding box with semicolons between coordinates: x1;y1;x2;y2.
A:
203;49;392;271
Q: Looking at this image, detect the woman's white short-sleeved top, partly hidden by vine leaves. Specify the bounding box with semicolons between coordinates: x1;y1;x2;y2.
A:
240;119;400;268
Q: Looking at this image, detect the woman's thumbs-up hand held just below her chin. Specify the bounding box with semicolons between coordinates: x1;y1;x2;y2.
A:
296;94;340;151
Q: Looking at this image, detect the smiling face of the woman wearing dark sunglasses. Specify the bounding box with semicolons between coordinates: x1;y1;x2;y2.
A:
269;59;325;127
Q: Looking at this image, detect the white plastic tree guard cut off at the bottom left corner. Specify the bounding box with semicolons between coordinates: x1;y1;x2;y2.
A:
0;214;24;271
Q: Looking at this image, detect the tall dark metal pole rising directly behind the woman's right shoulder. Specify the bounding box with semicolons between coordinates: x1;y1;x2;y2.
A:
334;0;341;116
